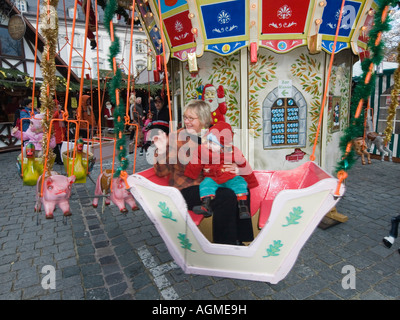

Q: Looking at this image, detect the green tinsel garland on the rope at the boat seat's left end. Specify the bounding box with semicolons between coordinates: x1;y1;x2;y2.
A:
104;0;129;177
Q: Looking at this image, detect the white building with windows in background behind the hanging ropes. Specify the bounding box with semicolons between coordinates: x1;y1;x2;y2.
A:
19;0;147;79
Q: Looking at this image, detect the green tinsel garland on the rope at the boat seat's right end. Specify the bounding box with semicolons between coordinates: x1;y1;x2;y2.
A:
336;0;398;172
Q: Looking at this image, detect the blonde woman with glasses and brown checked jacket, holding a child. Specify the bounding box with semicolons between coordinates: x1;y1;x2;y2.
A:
152;100;253;245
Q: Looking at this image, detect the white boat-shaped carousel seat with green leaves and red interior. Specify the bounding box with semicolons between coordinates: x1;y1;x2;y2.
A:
128;162;345;283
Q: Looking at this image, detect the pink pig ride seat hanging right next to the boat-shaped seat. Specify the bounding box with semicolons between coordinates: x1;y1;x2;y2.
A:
92;169;139;213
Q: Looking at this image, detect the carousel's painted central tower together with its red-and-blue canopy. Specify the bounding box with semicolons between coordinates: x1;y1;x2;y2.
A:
135;0;388;173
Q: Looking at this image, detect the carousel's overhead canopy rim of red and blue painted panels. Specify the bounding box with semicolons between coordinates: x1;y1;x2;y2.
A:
136;0;378;61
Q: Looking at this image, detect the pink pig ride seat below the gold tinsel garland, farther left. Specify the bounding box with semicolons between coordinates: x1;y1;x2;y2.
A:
35;174;76;219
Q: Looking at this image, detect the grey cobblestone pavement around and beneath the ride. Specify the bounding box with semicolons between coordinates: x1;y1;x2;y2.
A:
0;148;400;300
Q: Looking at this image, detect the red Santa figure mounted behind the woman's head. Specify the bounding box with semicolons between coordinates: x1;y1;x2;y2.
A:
202;84;227;125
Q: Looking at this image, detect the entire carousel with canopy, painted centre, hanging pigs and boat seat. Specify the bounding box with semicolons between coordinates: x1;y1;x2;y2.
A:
21;0;397;283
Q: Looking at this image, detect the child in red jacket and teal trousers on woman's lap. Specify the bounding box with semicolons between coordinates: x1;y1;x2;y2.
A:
185;122;258;219
